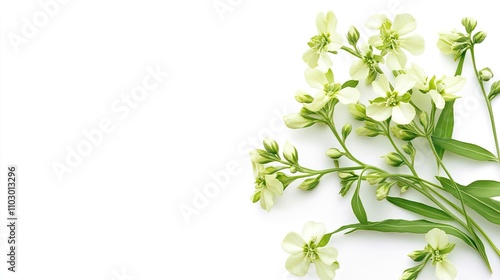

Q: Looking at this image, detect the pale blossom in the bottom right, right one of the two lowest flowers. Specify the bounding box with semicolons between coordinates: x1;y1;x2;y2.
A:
425;228;457;280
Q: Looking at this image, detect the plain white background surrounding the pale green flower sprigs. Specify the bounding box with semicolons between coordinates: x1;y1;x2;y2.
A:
0;0;500;280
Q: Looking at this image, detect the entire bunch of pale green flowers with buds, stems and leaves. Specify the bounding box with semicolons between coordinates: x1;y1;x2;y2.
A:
250;9;500;280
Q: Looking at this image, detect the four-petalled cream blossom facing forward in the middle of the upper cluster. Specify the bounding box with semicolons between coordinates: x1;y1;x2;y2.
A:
366;75;415;124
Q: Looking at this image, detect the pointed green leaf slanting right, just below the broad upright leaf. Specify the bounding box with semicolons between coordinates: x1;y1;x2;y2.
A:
432;136;498;162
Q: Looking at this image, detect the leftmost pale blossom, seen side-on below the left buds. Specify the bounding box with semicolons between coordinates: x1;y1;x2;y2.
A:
251;162;283;212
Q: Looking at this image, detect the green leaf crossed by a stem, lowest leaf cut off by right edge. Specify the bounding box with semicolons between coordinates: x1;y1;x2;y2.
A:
437;177;500;225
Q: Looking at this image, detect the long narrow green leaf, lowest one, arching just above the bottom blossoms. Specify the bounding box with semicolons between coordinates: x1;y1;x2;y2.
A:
333;219;478;253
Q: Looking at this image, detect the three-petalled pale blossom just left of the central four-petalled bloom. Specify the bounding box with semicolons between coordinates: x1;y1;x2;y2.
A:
304;69;360;112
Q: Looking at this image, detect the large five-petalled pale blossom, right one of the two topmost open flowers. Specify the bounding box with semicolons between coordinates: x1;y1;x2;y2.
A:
366;14;425;70
